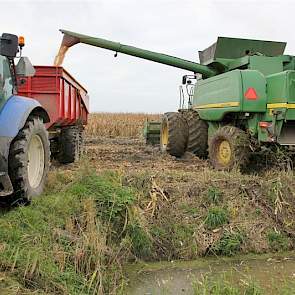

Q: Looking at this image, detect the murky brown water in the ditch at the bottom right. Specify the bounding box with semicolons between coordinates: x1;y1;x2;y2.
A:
126;252;295;295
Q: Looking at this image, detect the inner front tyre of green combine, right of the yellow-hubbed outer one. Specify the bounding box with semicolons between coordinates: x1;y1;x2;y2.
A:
183;110;208;158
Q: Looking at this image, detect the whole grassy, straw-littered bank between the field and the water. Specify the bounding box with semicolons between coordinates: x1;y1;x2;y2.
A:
0;165;295;294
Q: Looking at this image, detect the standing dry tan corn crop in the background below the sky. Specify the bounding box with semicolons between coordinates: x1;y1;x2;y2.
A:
86;113;160;138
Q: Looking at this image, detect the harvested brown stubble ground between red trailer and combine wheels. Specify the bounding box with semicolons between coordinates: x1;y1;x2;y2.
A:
86;138;208;173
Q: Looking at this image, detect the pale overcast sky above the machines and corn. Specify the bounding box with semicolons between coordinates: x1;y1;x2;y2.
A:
0;0;295;113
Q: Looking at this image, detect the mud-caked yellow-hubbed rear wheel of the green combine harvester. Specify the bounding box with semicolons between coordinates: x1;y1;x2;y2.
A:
209;126;250;171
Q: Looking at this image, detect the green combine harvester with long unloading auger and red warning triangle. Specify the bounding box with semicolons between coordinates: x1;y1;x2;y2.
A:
58;30;295;170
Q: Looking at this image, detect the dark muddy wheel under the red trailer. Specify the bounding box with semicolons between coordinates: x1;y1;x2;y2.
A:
58;126;82;164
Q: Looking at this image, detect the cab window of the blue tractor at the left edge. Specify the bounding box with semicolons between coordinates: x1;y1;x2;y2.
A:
0;56;13;103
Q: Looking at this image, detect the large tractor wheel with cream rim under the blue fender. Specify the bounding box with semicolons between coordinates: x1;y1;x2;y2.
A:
8;117;50;202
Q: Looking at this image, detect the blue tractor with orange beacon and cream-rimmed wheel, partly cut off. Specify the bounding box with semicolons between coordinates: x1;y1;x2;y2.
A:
0;33;50;201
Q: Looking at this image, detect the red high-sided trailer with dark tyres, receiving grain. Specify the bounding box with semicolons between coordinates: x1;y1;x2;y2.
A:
18;66;89;163
